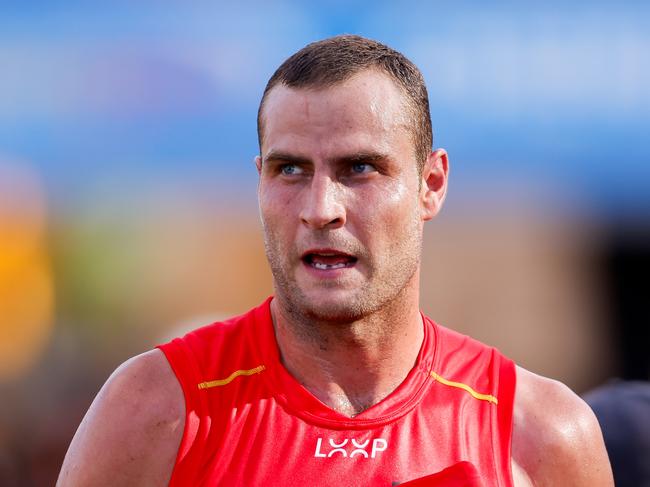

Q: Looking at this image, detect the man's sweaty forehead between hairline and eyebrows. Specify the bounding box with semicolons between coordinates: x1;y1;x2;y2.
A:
262;71;408;153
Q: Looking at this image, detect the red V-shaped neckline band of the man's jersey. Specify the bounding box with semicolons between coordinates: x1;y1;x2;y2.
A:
252;296;438;429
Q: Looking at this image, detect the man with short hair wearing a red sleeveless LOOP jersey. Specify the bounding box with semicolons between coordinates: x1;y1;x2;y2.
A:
59;36;612;487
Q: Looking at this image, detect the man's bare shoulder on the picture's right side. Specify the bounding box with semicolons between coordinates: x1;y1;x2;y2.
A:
512;367;614;487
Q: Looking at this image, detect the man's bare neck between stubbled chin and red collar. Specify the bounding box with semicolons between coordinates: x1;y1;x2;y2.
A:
271;292;424;417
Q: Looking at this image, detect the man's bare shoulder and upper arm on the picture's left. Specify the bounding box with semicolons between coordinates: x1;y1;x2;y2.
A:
57;349;185;486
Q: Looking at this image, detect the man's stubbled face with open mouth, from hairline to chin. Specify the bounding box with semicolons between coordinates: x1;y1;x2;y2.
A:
256;70;430;322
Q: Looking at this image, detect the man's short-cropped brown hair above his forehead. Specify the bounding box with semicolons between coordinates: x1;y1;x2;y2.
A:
257;35;433;172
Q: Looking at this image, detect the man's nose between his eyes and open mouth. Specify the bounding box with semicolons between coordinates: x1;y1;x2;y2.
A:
296;175;345;230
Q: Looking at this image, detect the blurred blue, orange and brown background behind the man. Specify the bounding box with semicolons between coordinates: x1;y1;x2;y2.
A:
0;0;650;486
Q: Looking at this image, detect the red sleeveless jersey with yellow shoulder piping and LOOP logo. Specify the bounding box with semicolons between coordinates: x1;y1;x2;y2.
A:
159;298;515;487
